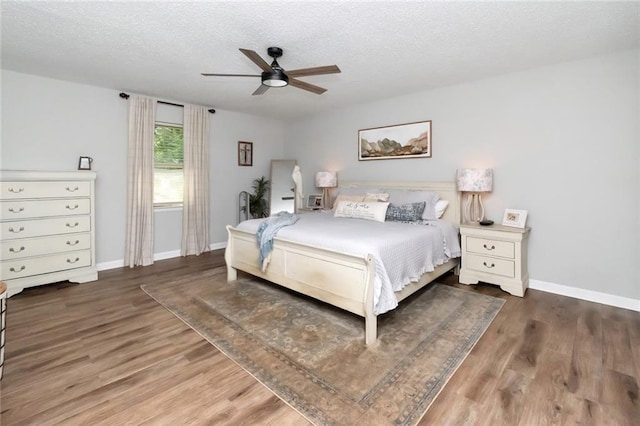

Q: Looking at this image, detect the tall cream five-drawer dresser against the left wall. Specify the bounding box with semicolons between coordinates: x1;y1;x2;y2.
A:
0;170;98;297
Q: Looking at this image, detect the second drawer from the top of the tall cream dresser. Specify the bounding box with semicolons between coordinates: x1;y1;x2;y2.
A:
0;198;91;220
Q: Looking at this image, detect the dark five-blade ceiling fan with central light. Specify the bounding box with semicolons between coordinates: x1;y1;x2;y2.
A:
202;47;340;95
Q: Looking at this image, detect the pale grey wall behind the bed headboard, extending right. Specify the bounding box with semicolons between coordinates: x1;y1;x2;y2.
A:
286;51;640;306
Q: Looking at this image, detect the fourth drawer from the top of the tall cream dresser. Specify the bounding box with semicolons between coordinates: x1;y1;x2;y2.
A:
0;234;91;260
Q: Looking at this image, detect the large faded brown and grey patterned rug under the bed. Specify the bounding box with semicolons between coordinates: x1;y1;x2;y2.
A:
142;272;504;425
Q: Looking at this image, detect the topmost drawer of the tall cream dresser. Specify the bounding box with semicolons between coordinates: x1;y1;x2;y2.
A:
0;181;91;200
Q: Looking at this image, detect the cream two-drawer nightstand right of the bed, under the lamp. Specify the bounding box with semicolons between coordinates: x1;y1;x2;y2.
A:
460;223;531;297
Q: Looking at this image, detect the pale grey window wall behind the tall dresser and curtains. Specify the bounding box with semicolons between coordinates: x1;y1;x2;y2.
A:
0;70;284;267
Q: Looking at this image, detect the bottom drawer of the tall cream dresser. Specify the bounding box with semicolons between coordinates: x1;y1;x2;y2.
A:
0;250;91;280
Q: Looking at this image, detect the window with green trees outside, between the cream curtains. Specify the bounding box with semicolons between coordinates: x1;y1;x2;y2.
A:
153;123;184;207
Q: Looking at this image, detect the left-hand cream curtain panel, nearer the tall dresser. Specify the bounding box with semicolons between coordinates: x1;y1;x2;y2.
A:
124;96;157;268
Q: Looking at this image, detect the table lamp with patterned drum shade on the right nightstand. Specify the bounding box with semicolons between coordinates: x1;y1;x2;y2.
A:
456;169;493;223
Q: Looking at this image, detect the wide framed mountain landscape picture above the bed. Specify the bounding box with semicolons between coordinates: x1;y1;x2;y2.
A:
358;120;432;161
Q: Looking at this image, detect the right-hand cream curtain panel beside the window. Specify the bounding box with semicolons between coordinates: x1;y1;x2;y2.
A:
180;105;209;256
